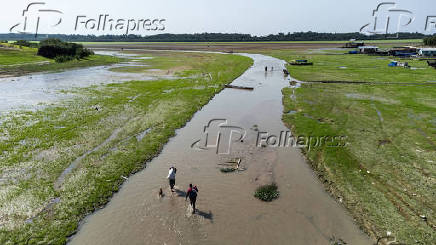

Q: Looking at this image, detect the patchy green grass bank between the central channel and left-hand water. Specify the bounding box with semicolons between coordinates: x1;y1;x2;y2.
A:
0;51;252;244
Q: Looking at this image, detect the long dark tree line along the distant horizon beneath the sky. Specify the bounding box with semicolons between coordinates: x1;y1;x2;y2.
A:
0;31;430;42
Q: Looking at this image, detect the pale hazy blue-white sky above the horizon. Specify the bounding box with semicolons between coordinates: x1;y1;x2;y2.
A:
0;0;436;35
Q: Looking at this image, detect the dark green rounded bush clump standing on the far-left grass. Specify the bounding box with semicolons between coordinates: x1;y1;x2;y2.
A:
38;38;94;62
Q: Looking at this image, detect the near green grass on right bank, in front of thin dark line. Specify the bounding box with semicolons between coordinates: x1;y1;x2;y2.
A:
283;84;436;244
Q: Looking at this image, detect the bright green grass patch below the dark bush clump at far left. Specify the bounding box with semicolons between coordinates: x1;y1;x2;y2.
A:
0;42;121;76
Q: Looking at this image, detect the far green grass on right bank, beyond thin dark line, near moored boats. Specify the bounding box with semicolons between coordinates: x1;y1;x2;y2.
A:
268;50;436;83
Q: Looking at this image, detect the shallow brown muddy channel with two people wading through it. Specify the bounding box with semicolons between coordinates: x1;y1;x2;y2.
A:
70;55;371;245
